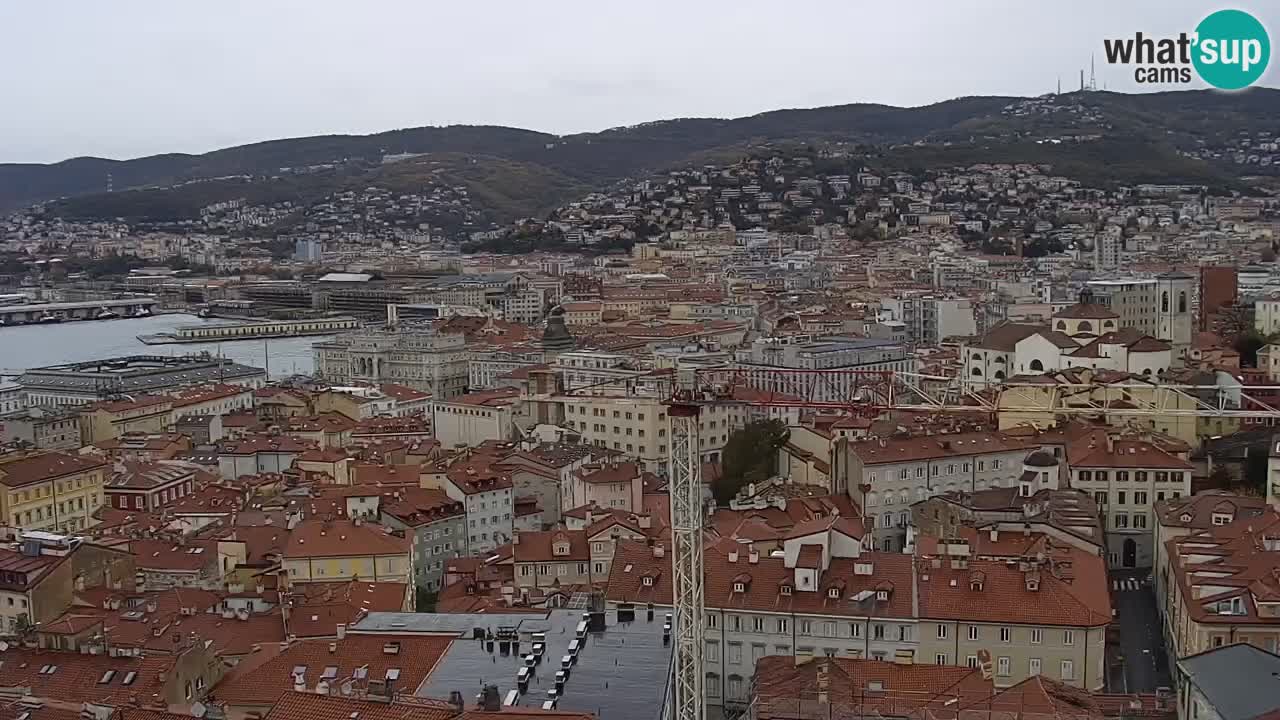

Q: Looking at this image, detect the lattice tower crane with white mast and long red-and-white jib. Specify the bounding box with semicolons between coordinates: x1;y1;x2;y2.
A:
667;366;1280;720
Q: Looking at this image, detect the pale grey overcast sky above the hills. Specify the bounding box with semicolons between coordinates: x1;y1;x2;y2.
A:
0;0;1280;163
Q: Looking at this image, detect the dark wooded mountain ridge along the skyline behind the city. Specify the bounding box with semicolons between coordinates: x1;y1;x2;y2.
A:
0;88;1280;210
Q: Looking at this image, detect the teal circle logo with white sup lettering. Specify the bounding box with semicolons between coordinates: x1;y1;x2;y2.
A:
1192;10;1271;90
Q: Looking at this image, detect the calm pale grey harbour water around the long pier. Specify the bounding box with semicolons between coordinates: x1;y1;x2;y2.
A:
0;315;328;378
